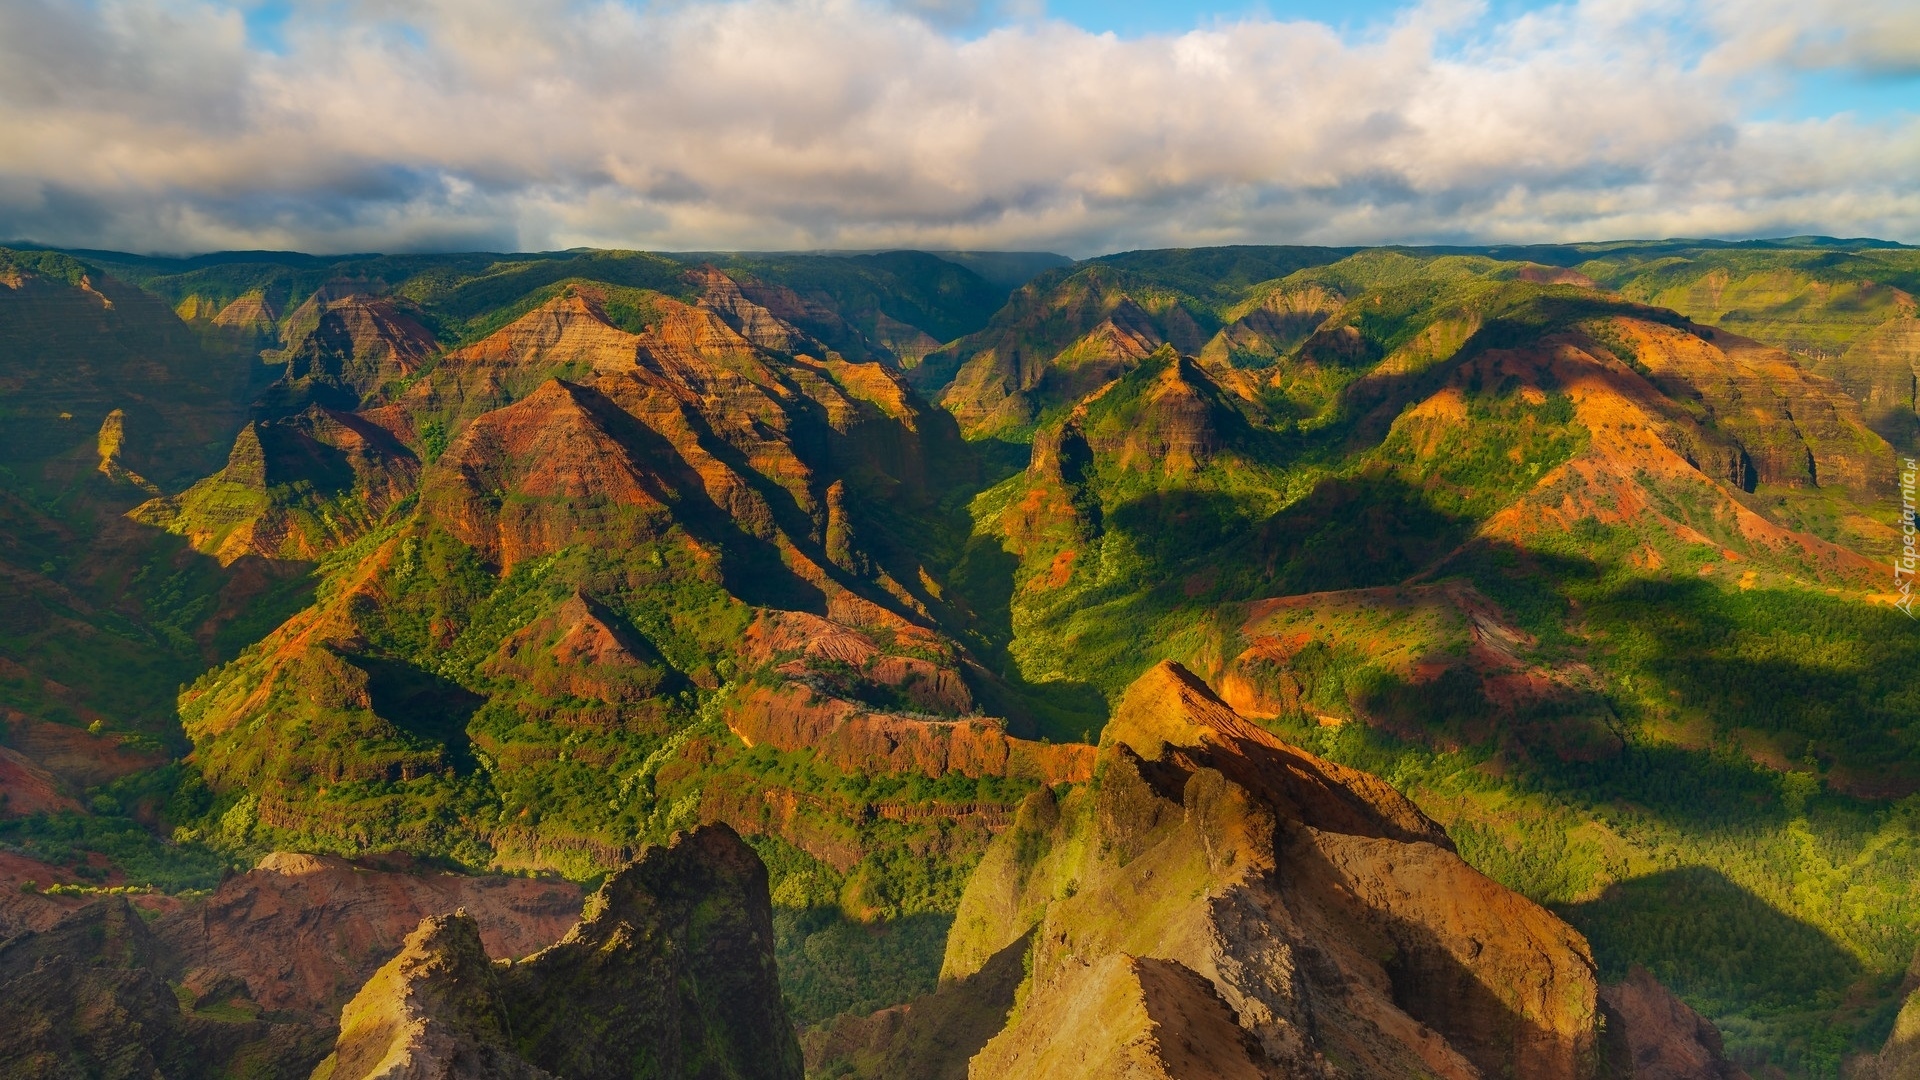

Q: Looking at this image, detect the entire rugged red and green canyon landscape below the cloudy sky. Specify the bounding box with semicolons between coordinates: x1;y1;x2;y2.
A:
0;236;1920;1080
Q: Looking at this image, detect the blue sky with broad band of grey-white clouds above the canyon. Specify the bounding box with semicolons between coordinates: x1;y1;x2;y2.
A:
0;0;1920;258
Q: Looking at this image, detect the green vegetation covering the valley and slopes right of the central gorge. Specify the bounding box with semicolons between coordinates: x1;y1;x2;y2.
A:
921;252;1920;1076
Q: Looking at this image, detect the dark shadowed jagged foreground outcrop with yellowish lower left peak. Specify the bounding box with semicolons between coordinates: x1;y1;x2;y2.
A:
315;824;803;1080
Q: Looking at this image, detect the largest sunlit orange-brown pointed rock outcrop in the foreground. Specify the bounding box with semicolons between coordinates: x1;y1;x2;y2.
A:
929;665;1601;1078
